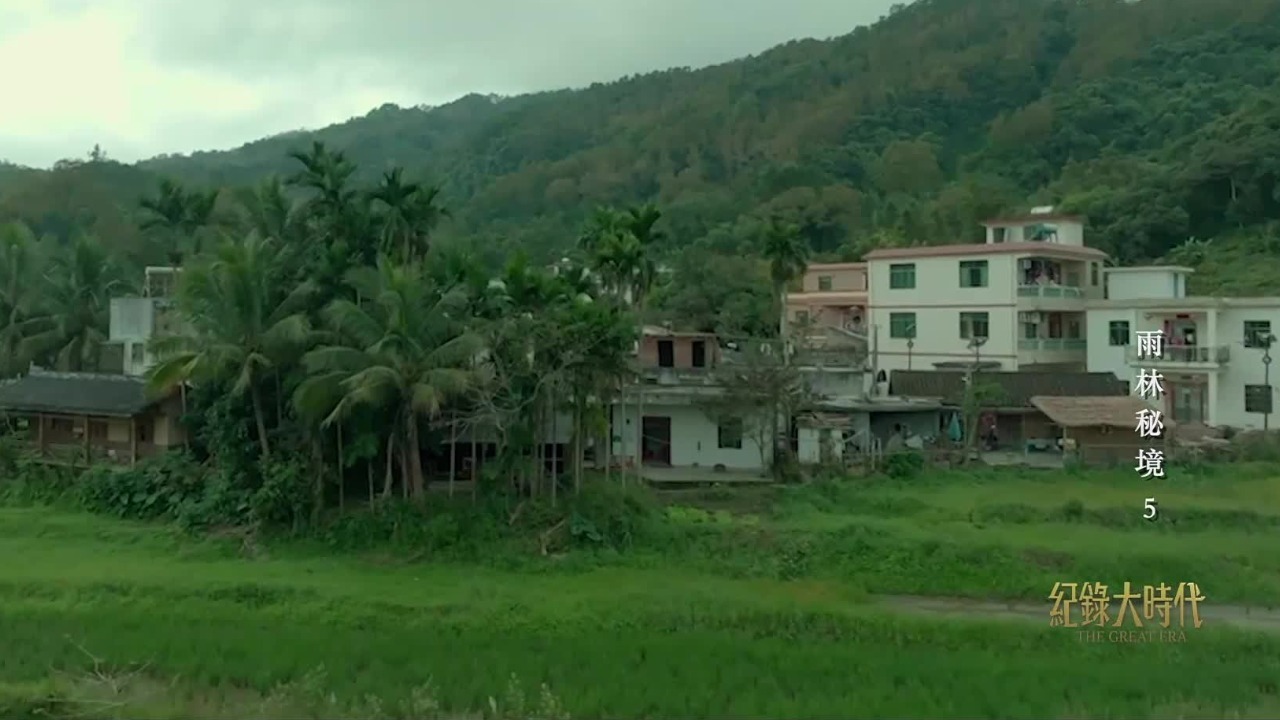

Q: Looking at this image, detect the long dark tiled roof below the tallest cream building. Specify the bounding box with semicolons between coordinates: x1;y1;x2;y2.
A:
888;370;1128;409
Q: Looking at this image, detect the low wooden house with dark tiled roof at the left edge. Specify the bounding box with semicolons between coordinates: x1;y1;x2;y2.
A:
0;368;186;464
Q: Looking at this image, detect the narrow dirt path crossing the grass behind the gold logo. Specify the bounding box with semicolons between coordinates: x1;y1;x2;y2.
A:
876;596;1280;633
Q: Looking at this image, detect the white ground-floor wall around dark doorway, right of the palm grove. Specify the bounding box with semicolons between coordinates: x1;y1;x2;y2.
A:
613;401;769;470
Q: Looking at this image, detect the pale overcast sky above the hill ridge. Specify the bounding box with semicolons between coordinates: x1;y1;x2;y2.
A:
0;0;892;167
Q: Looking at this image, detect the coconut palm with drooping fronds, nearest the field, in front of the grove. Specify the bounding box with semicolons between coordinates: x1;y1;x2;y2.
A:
293;261;481;497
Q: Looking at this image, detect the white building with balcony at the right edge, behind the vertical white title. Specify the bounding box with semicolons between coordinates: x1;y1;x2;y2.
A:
1085;266;1280;429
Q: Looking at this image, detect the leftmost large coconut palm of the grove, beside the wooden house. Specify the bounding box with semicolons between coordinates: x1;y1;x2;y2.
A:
148;234;315;457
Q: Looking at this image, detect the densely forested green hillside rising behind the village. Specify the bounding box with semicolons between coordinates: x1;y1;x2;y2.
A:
0;0;1280;292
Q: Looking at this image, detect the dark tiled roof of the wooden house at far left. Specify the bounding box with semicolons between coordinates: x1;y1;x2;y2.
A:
0;368;152;418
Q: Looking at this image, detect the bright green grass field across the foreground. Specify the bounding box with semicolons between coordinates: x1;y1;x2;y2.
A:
0;466;1280;719
